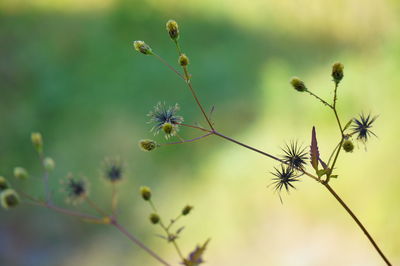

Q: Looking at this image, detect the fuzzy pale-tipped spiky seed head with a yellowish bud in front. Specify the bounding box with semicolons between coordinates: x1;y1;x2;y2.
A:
147;102;183;138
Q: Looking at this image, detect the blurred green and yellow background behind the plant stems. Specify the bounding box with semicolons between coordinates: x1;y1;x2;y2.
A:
0;0;400;266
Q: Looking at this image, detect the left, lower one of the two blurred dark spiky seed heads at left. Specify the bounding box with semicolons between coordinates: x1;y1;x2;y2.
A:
62;175;89;204
